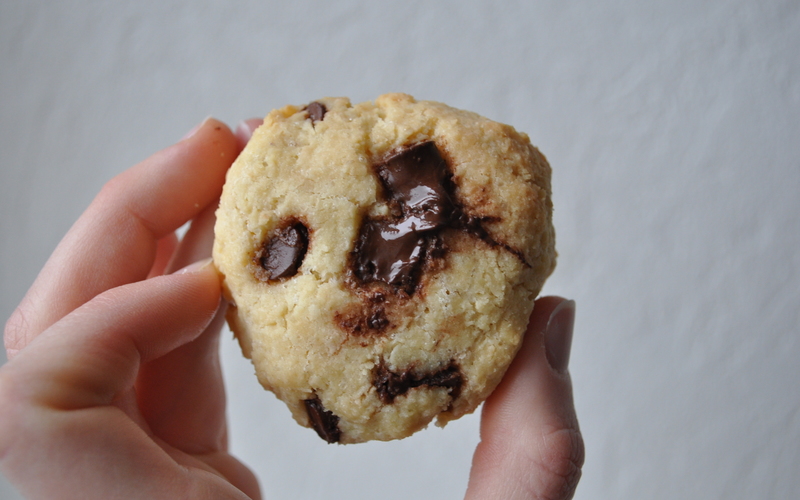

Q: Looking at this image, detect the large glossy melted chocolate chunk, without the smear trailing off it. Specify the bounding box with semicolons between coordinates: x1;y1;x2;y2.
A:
353;142;455;295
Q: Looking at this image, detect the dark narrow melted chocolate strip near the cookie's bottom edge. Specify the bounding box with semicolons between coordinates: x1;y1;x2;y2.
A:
372;359;464;405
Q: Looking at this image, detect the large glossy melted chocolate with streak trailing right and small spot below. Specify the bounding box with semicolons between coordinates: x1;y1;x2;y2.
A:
340;141;528;334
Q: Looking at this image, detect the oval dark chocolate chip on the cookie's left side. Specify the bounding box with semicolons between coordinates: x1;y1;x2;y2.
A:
254;221;308;281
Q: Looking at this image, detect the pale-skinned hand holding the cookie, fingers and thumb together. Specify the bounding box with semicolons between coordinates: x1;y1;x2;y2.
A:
0;119;584;500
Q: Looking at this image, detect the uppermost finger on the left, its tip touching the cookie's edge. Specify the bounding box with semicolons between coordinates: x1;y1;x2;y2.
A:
5;118;240;358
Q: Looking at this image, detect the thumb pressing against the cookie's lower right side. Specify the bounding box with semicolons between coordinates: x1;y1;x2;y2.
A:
466;297;584;500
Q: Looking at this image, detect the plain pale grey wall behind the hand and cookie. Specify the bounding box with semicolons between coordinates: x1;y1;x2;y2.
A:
0;0;800;500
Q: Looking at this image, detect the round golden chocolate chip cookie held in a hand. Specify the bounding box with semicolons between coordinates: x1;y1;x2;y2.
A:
214;94;556;443
